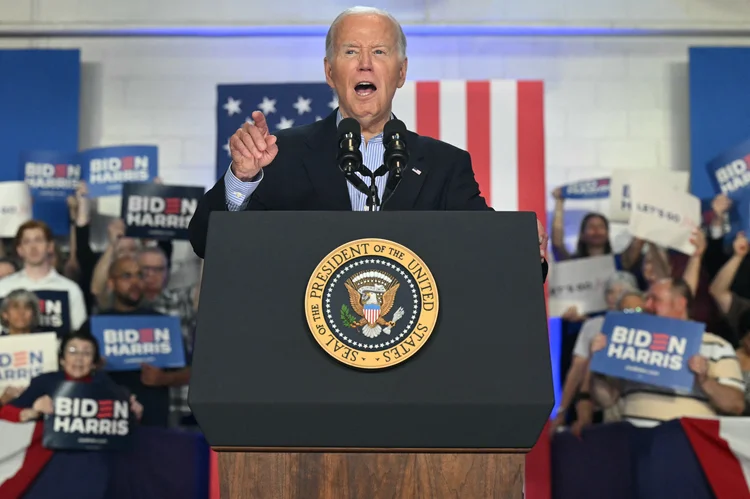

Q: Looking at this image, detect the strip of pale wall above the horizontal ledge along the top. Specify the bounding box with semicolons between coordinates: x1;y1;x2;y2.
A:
8;0;750;27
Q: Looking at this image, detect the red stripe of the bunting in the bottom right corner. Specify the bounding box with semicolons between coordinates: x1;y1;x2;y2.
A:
680;418;750;499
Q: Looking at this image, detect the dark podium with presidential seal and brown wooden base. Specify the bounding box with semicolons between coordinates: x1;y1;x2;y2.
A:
189;212;554;499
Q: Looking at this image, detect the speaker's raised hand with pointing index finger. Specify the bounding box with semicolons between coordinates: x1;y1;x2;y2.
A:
229;111;279;182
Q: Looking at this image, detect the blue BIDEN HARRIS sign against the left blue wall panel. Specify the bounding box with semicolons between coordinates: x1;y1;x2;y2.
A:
21;151;83;235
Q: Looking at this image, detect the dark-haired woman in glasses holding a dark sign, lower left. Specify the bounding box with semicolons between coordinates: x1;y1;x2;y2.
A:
0;332;143;422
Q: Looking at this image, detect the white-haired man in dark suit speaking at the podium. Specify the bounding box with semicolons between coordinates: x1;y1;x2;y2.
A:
190;7;547;279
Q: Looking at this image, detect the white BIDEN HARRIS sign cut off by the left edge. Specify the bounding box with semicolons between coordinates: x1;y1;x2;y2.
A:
0;333;58;393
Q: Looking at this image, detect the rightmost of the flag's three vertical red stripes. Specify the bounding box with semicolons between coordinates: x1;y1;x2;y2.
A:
517;81;547;221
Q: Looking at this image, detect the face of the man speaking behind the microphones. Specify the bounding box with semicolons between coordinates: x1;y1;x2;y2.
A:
325;15;407;129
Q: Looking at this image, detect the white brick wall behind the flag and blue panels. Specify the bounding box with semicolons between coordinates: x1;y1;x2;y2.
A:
0;0;750;194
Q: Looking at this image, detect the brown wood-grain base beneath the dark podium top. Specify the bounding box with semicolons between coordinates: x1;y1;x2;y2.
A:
216;449;525;499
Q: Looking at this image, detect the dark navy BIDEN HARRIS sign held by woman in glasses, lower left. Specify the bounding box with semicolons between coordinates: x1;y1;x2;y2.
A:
42;380;135;450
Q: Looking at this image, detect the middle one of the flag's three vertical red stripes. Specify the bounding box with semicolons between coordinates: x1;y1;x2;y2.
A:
466;81;492;206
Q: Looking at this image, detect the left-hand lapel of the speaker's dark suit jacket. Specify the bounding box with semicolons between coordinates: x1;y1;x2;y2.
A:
303;110;352;211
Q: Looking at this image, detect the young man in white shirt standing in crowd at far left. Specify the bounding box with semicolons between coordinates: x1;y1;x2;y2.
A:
0;220;87;331
